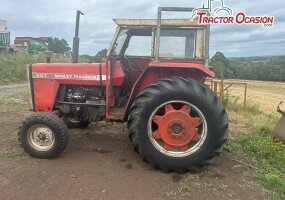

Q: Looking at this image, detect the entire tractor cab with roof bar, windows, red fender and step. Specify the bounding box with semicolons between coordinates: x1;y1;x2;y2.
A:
106;8;211;120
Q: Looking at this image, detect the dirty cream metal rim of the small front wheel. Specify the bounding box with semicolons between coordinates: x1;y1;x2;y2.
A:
27;125;55;151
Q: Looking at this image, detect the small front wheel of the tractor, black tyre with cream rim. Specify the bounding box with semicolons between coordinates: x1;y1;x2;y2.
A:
18;112;68;158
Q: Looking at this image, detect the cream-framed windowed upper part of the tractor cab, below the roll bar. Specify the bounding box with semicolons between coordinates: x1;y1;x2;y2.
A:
107;19;208;64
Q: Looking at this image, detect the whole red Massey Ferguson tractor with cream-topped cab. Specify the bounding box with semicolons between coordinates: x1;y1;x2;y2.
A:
19;7;228;173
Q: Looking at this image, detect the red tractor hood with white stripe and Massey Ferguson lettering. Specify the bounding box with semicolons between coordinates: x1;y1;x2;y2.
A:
28;63;124;112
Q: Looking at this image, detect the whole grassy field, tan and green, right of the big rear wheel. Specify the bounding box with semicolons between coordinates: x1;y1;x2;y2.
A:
222;80;285;199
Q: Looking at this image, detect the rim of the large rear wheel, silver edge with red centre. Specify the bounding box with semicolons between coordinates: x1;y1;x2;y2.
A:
148;101;208;157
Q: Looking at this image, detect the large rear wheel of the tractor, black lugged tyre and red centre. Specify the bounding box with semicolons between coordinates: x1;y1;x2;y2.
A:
128;78;228;173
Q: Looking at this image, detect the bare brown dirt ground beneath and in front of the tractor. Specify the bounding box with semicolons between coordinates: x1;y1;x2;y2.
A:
0;82;268;200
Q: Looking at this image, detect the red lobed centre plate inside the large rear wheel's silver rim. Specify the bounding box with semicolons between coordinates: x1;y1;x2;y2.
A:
153;104;202;151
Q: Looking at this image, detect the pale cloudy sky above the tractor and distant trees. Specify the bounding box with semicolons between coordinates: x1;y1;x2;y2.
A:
0;0;285;57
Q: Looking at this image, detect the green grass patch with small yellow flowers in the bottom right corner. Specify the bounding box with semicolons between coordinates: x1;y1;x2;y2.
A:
235;125;285;199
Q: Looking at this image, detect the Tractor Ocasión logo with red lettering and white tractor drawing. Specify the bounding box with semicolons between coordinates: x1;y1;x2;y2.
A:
192;0;274;27
